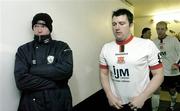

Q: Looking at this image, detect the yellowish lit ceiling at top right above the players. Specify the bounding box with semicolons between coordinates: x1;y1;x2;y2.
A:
122;0;180;17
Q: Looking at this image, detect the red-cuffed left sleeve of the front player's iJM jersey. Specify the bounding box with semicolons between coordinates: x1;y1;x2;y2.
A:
99;45;108;69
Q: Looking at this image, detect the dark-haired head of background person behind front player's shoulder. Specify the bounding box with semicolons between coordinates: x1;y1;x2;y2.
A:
141;27;151;39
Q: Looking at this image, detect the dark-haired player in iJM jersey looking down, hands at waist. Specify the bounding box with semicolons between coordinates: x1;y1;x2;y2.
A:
100;9;163;111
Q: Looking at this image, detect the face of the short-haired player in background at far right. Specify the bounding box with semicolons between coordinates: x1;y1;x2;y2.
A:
156;24;167;38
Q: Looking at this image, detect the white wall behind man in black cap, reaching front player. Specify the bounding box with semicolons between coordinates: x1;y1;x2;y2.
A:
0;0;133;111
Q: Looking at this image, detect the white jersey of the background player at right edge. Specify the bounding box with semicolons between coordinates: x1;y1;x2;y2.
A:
153;36;180;76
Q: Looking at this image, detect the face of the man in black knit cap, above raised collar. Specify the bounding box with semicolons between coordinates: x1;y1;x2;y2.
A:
33;24;50;36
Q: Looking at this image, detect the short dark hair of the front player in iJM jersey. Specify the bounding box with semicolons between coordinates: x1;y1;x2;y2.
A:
112;8;134;24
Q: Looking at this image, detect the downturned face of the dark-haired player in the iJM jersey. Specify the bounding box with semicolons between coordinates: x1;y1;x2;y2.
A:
112;15;130;41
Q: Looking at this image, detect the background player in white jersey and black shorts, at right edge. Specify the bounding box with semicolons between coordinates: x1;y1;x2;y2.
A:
152;21;180;111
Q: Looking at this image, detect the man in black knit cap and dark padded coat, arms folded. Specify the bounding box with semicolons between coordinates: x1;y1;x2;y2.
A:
14;13;73;111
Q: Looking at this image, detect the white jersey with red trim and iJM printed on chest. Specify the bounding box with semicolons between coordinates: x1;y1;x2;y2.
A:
100;36;162;104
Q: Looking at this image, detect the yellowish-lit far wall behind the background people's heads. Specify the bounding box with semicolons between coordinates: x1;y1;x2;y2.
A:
134;17;180;39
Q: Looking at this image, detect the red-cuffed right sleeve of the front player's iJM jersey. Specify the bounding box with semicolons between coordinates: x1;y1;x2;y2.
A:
148;41;162;70
